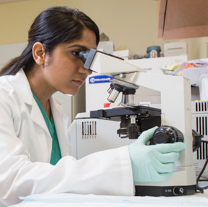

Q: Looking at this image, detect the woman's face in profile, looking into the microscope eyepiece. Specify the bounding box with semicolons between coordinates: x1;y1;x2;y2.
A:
43;29;97;95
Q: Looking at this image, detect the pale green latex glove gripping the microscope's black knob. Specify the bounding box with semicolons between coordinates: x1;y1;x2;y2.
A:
129;127;186;183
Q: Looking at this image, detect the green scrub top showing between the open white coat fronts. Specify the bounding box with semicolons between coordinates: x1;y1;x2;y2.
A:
33;93;61;165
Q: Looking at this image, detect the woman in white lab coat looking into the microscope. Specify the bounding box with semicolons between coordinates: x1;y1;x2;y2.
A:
0;7;184;205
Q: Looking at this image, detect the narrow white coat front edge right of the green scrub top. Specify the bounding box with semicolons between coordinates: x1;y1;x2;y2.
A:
50;96;68;157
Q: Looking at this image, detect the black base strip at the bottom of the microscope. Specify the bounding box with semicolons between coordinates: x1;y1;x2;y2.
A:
135;185;196;196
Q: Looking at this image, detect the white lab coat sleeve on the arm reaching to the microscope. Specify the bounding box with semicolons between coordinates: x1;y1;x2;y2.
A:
0;98;134;205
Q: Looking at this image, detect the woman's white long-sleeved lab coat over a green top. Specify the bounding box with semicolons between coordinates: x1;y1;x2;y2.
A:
0;70;134;205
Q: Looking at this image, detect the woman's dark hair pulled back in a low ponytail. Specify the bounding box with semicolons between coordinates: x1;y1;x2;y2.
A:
0;6;99;76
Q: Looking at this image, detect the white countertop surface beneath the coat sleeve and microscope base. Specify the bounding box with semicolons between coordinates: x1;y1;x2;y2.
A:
12;190;208;207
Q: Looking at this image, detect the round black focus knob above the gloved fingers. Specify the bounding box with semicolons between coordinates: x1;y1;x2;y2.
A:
150;125;184;145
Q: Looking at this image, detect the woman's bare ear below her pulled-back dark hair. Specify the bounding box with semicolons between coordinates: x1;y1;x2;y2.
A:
32;42;45;65
